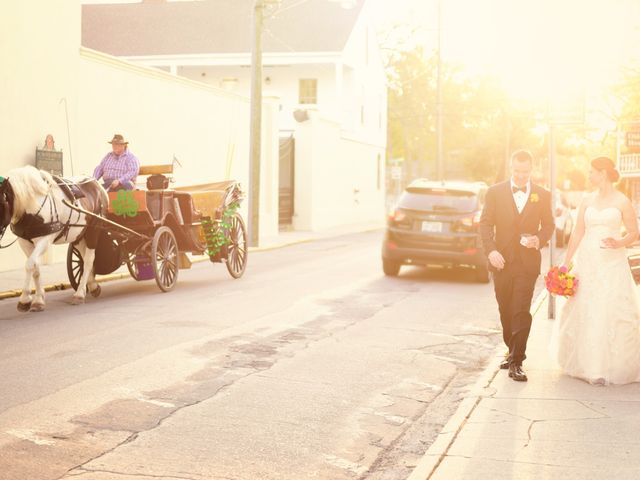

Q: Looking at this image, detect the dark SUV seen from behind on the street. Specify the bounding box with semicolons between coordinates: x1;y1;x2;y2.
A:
382;180;489;283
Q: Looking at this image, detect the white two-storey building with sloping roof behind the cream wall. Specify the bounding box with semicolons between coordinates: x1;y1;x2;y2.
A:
82;0;387;230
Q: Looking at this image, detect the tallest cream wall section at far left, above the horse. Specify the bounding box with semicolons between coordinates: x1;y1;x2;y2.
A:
0;0;80;270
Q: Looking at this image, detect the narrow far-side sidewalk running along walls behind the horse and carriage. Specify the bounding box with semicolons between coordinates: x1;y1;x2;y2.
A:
0;222;384;300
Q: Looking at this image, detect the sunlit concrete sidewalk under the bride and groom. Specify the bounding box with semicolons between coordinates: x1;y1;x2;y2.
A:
409;292;640;480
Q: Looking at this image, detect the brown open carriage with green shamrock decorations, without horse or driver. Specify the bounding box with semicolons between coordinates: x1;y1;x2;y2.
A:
65;165;248;292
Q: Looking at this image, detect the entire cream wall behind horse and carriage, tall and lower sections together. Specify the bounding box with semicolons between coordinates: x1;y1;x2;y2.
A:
0;0;278;274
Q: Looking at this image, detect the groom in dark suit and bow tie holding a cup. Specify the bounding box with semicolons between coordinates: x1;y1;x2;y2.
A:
480;150;555;382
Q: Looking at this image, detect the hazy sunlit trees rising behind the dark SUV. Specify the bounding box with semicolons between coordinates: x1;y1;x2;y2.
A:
387;48;546;183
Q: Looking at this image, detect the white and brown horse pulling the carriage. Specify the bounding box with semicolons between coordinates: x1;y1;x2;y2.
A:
0;165;109;312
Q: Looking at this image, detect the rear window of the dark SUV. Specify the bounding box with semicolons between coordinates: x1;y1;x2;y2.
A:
398;188;479;212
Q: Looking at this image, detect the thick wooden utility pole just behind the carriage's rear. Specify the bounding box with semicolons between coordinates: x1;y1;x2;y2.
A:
249;0;264;247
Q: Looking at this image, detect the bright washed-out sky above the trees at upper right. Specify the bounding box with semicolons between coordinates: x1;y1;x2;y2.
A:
373;0;640;104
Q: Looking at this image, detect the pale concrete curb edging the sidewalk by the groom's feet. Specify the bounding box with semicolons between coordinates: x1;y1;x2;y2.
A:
407;290;547;480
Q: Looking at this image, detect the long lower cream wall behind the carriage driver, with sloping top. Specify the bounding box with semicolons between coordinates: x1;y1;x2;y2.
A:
76;49;278;242
